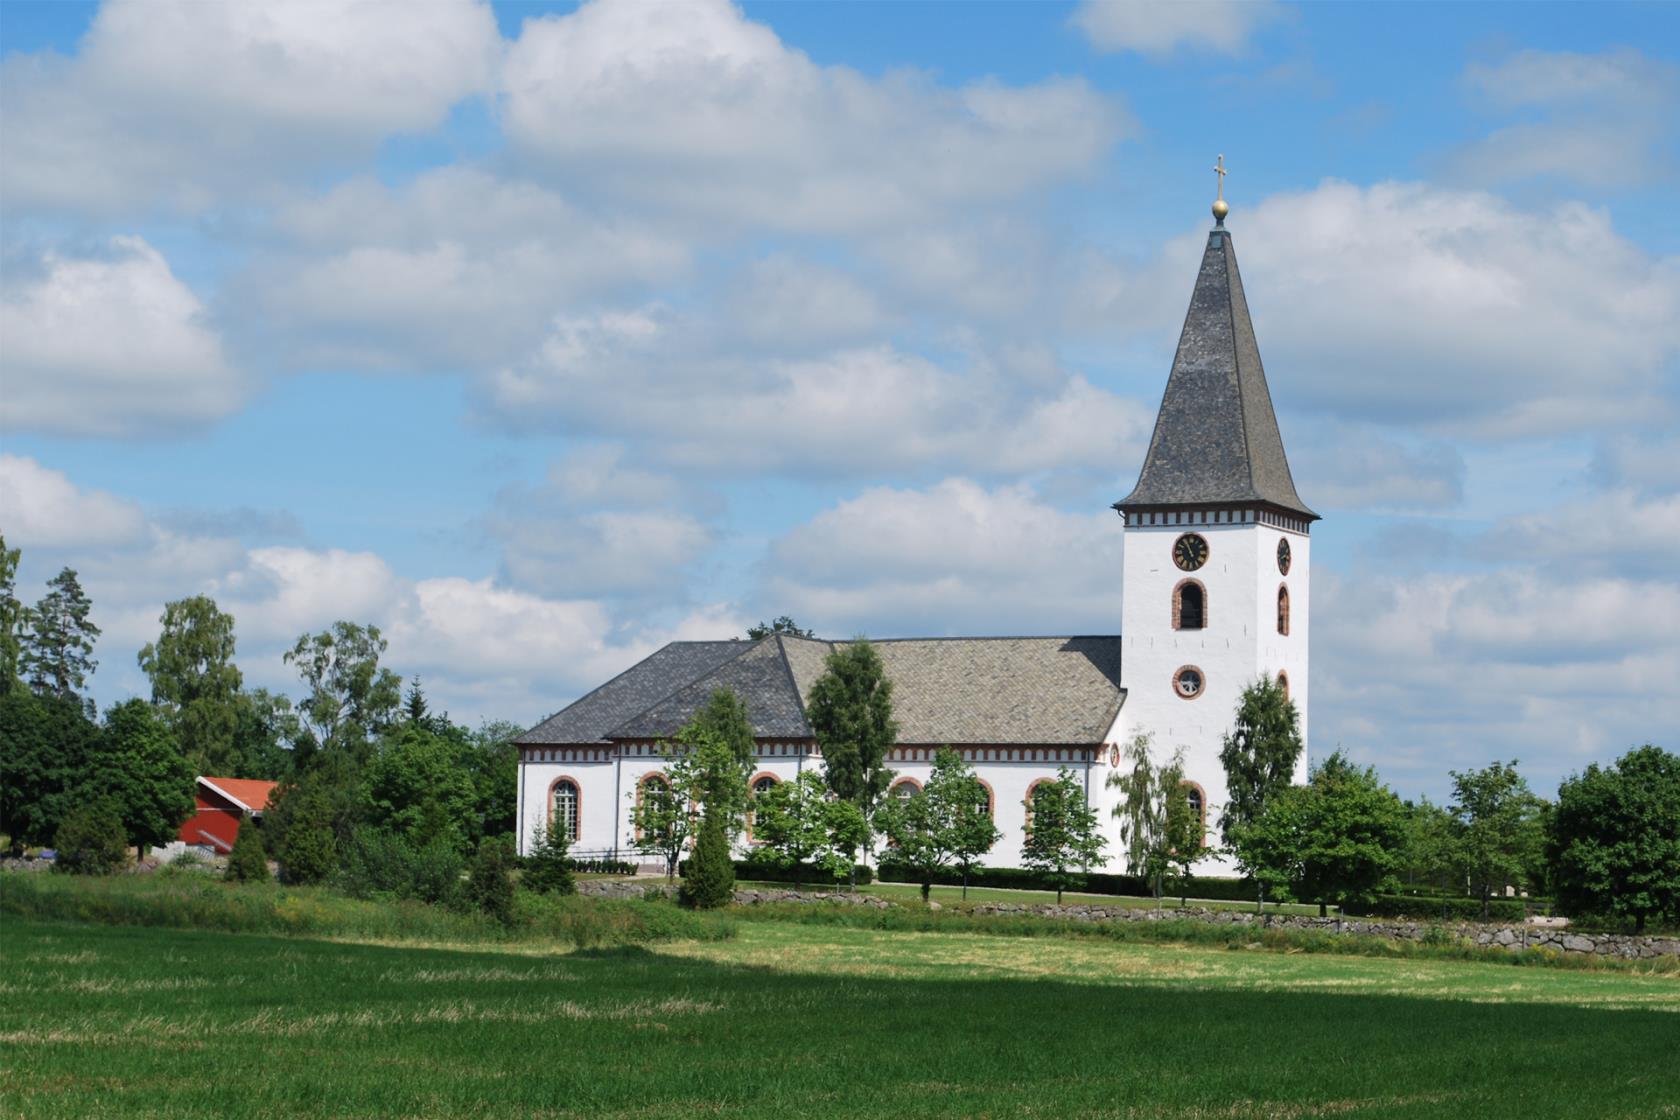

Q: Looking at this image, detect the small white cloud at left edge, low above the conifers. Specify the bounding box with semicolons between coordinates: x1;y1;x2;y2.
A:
0;453;143;551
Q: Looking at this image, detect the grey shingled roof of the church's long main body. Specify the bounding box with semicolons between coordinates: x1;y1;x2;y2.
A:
519;635;1126;746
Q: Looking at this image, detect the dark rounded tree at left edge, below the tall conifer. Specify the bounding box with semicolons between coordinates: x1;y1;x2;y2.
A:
0;688;102;851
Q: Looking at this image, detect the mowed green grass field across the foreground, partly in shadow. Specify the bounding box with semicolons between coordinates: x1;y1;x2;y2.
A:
0;919;1680;1120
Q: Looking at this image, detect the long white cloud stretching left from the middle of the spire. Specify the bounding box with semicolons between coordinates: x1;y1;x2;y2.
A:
480;307;1151;475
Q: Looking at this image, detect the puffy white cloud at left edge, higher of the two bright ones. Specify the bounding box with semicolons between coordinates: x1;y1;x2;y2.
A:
0;237;245;437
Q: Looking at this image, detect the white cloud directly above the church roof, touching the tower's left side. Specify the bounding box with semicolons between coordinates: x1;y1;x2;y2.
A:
761;479;1121;636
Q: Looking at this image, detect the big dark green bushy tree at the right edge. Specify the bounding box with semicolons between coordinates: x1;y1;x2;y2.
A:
1547;744;1680;934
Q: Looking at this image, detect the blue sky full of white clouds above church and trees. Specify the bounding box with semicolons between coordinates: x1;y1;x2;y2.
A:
0;0;1680;799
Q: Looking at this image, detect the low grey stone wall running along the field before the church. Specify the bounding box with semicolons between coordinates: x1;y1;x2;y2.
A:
578;880;1680;960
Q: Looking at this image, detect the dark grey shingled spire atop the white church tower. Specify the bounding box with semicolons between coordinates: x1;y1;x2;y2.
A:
1114;228;1319;521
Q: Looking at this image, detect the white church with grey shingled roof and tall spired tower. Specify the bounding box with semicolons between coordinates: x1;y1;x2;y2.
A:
517;183;1317;875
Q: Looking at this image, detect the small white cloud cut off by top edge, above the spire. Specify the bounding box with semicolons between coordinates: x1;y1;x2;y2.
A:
1068;0;1282;55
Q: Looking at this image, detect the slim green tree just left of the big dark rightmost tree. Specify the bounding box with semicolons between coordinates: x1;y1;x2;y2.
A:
1448;759;1544;920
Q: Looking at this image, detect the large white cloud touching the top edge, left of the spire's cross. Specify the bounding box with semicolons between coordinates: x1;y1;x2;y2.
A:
502;0;1129;232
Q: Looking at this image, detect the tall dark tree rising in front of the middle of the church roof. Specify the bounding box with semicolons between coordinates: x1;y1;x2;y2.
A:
805;638;899;886
